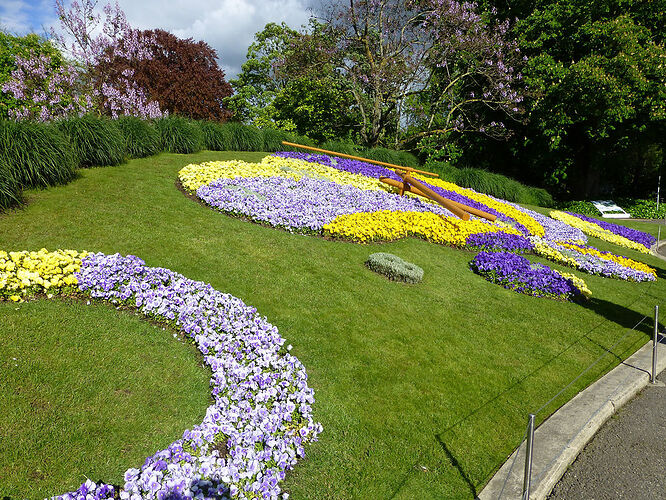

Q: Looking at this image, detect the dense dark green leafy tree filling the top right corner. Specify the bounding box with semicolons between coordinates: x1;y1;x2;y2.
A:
474;0;666;199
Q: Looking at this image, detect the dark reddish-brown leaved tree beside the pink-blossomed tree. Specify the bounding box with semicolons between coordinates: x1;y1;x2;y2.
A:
97;29;232;121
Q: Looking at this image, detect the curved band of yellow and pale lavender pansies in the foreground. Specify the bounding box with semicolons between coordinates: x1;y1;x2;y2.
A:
0;249;322;500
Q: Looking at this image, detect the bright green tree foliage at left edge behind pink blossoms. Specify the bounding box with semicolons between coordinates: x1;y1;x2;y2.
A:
0;31;65;120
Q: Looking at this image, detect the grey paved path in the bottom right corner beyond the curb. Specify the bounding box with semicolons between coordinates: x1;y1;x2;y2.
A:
548;372;666;500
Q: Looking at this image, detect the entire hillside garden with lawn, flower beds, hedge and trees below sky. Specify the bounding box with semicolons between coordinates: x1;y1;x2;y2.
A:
0;0;666;500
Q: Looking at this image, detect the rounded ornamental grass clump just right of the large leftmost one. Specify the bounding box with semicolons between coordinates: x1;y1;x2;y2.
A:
56;115;125;167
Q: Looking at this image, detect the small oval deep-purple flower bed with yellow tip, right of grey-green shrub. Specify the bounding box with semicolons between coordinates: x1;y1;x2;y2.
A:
470;252;587;300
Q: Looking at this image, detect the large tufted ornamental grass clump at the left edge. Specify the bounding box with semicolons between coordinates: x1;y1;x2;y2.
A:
0;120;76;189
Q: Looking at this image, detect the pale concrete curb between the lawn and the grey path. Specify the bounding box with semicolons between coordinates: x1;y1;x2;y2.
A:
477;338;666;500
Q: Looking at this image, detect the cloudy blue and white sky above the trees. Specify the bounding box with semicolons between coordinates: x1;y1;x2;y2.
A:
0;0;321;80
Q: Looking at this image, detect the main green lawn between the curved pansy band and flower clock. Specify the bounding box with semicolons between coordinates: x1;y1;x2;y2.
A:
0;152;666;499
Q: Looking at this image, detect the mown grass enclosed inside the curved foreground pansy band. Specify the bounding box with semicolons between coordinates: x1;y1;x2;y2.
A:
0;300;210;499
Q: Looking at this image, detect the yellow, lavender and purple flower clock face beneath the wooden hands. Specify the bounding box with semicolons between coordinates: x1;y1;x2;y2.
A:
178;152;656;300
